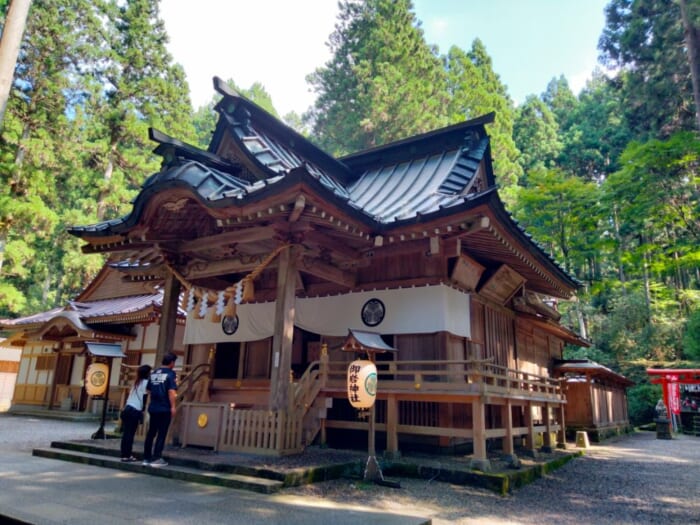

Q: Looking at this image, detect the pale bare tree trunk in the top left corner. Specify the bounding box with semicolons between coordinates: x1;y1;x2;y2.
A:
0;0;32;129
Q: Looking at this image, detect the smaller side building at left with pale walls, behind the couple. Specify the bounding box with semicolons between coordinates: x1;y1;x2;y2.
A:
0;264;184;415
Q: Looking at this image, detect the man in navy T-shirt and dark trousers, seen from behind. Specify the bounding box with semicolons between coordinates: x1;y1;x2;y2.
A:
143;352;177;467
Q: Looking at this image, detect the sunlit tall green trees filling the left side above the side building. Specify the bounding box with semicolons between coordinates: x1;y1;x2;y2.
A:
0;0;193;316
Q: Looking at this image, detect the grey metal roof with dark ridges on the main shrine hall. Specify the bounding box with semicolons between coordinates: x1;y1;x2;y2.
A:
68;79;580;295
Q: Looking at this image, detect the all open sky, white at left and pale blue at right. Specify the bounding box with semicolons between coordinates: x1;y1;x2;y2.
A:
161;0;609;114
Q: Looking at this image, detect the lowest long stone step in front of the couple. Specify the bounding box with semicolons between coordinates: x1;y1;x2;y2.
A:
32;447;283;494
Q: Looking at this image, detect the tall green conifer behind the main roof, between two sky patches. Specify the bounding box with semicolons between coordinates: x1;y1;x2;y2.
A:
305;0;447;154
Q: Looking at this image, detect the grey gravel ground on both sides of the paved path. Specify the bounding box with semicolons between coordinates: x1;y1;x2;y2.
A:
0;414;700;525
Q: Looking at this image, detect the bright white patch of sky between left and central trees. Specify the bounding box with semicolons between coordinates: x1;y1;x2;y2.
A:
161;0;337;115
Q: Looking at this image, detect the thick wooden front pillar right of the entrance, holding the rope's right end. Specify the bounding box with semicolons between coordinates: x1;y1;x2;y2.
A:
270;244;297;410
